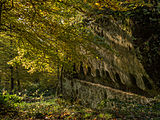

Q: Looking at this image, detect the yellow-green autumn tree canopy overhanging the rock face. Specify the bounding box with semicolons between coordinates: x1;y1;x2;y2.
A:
0;0;160;73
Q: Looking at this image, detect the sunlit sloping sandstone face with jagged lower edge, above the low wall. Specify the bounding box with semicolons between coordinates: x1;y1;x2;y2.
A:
75;18;158;96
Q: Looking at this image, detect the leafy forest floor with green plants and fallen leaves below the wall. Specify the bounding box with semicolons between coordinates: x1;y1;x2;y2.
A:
0;95;160;120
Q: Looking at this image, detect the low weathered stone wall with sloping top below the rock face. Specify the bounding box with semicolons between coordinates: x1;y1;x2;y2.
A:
62;79;150;108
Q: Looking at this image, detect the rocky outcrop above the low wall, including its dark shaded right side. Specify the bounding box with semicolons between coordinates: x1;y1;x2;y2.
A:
74;8;160;97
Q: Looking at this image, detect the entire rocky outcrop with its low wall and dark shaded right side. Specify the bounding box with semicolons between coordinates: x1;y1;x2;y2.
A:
61;6;160;111
